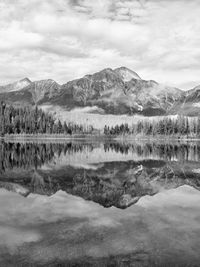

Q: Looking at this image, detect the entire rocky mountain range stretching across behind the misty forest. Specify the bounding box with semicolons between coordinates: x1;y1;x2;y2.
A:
0;67;200;116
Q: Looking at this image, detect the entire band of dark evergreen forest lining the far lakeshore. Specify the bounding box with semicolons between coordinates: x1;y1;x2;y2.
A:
0;102;200;138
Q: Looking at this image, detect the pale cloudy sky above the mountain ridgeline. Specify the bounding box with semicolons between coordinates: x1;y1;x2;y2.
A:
0;0;200;90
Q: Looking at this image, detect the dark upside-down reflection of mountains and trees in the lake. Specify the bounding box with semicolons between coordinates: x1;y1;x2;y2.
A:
0;142;200;208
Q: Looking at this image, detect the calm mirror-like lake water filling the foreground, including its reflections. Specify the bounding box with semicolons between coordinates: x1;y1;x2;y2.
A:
0;141;200;267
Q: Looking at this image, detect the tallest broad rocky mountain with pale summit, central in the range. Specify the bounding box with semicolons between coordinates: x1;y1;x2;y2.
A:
50;67;183;115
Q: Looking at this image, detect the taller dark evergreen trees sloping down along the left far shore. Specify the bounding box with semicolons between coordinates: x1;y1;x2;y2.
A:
0;102;93;136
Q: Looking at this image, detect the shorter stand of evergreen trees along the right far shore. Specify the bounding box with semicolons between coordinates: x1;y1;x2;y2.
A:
104;116;200;137
